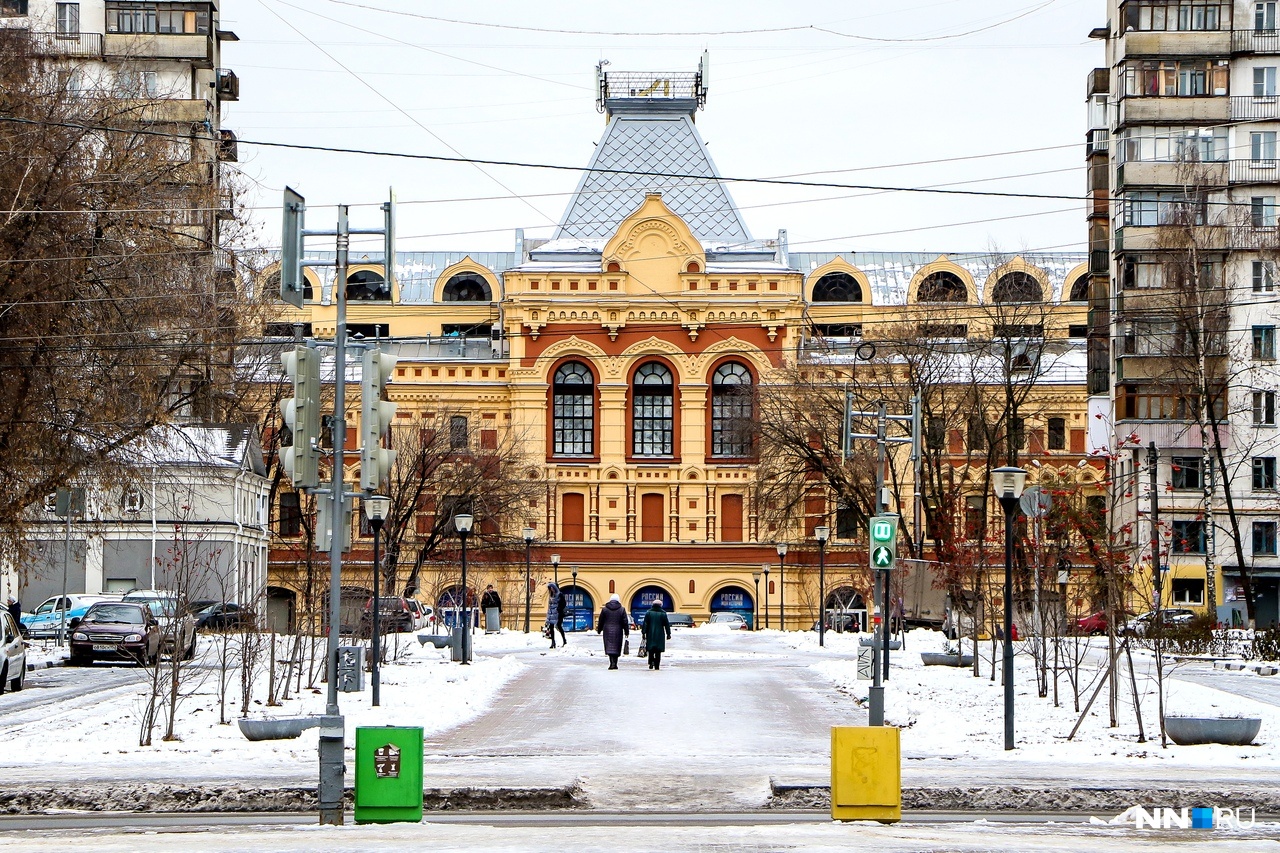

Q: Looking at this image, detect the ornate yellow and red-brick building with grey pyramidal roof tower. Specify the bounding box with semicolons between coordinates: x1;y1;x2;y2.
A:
257;64;1100;628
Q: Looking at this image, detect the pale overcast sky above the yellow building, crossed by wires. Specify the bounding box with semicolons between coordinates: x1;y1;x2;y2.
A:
221;0;1106;252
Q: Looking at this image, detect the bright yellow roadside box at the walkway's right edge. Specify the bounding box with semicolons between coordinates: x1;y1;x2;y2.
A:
831;726;902;824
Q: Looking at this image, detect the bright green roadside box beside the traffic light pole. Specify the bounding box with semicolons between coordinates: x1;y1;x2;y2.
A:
356;726;422;824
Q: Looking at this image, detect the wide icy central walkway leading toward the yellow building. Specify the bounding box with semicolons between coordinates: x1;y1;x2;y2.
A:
426;631;867;809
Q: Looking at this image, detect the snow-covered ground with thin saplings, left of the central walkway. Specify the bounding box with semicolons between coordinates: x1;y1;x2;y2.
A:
0;627;526;783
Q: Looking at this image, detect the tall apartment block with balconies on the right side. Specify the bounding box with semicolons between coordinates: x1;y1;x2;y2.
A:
1087;0;1280;625
